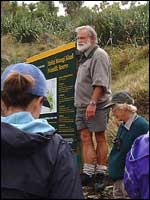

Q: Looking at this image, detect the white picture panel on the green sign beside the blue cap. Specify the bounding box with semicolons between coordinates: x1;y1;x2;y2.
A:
41;78;57;114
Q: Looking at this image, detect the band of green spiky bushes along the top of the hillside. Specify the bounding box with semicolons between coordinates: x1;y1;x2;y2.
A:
1;1;149;46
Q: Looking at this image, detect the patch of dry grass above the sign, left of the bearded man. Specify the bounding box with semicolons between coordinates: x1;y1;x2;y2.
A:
1;34;64;63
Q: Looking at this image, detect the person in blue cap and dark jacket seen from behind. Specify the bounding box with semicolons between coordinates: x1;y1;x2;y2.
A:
1;63;83;199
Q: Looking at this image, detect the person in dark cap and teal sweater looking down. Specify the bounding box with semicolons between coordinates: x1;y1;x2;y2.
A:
102;91;149;199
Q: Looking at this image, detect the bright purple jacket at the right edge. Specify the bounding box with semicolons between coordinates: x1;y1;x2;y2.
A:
124;133;149;199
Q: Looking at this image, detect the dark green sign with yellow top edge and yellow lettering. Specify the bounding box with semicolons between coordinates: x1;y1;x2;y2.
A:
27;42;77;148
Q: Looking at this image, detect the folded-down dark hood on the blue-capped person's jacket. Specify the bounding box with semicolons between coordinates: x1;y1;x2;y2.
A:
1;122;55;156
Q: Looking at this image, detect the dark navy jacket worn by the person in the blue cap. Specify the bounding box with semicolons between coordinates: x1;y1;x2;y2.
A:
1;123;83;199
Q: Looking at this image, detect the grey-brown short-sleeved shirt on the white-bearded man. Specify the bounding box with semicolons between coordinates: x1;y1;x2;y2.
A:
74;45;111;107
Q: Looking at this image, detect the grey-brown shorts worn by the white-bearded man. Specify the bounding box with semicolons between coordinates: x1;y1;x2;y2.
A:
76;108;110;133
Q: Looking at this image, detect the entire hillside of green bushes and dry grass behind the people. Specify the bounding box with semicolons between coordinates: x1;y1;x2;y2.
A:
1;1;149;199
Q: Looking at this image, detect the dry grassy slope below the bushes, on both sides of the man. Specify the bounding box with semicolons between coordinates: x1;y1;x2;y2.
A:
1;35;149;146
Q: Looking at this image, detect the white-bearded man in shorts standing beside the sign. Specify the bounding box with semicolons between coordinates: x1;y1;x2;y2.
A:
74;25;111;186
